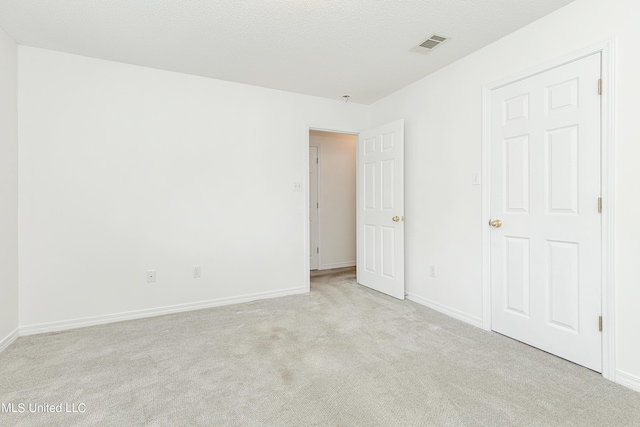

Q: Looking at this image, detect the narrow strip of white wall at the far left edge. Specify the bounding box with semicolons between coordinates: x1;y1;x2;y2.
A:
0;26;18;349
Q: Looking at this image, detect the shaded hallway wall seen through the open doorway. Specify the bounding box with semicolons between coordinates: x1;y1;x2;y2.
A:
309;131;358;270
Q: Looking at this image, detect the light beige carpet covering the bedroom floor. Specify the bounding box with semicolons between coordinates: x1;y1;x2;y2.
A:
0;269;640;427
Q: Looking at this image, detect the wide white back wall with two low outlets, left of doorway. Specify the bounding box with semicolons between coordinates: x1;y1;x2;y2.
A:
19;46;368;333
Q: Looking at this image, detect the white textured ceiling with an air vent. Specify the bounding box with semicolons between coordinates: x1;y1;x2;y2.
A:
0;0;572;104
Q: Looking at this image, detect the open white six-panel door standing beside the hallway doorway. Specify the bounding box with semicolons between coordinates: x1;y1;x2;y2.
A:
357;120;404;299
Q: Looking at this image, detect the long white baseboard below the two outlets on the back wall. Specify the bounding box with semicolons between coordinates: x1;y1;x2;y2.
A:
20;287;309;336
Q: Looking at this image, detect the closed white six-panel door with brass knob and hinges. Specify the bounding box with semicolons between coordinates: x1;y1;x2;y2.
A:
486;53;602;372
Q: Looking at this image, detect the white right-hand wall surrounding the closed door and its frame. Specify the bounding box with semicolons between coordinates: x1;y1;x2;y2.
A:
372;0;640;387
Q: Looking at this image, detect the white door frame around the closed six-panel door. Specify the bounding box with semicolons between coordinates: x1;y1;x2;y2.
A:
482;39;616;381
